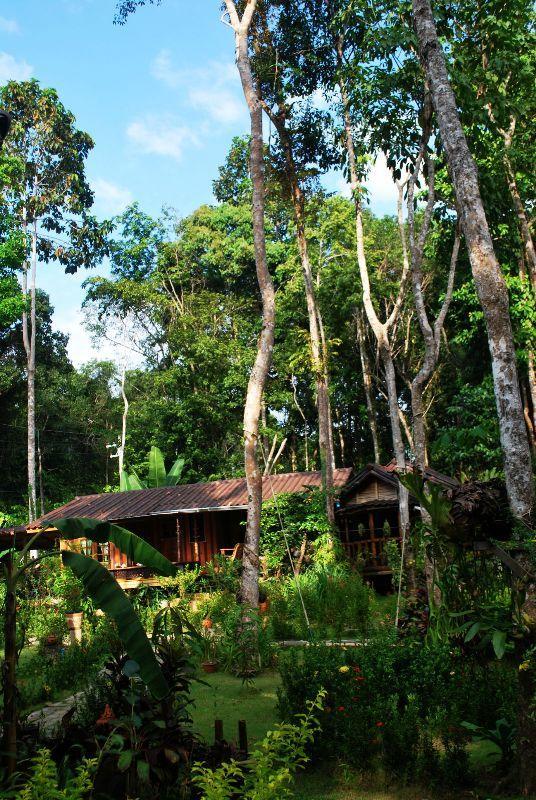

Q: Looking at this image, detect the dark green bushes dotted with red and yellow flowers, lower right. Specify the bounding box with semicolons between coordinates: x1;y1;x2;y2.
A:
278;632;516;783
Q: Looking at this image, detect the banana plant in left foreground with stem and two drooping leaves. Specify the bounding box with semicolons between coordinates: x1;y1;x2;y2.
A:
0;517;177;774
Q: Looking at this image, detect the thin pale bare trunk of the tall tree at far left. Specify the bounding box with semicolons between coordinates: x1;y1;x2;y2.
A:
22;216;37;522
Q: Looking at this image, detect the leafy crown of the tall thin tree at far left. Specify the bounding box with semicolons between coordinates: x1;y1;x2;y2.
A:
0;80;109;272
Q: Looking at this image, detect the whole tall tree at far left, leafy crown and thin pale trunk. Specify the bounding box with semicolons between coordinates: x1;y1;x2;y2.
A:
0;80;108;521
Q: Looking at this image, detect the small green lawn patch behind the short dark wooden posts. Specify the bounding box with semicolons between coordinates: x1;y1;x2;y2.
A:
192;672;279;743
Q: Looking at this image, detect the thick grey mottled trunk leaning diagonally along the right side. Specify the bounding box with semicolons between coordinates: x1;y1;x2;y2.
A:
412;0;534;519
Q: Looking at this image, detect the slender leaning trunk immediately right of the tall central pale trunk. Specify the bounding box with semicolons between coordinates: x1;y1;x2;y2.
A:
264;111;335;525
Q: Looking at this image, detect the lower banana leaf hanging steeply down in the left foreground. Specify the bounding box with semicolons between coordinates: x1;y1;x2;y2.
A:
61;550;169;700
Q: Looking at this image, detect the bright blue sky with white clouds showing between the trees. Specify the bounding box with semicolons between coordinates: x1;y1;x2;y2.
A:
0;0;394;364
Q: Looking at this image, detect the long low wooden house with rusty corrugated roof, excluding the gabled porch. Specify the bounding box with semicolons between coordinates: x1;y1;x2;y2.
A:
17;468;352;588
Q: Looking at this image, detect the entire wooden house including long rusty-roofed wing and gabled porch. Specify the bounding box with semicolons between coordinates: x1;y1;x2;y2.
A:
0;462;457;588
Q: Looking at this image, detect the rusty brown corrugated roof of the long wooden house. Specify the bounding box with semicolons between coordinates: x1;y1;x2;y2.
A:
32;467;352;528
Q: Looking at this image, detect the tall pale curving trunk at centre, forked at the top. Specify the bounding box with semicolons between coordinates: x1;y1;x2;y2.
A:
225;0;275;608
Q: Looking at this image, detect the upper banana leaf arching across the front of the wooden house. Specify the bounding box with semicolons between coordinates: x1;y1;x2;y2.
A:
51;517;177;578
